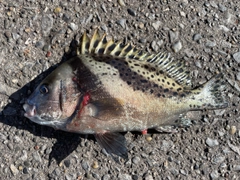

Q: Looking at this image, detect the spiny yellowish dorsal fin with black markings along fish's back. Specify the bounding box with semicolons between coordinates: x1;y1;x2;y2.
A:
77;29;192;89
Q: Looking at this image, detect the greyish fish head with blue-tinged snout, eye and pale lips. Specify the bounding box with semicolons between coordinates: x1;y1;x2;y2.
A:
23;63;82;129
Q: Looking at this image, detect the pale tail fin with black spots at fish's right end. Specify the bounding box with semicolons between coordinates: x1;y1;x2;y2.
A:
193;73;228;109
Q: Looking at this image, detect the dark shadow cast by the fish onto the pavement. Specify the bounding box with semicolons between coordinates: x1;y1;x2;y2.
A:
0;40;91;165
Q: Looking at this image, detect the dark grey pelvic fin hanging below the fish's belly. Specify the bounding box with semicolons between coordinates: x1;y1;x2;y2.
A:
95;132;128;160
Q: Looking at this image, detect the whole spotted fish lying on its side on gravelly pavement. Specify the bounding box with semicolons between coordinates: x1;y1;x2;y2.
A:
23;30;227;157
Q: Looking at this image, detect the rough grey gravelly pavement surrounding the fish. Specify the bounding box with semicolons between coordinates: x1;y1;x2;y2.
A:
0;0;240;180
